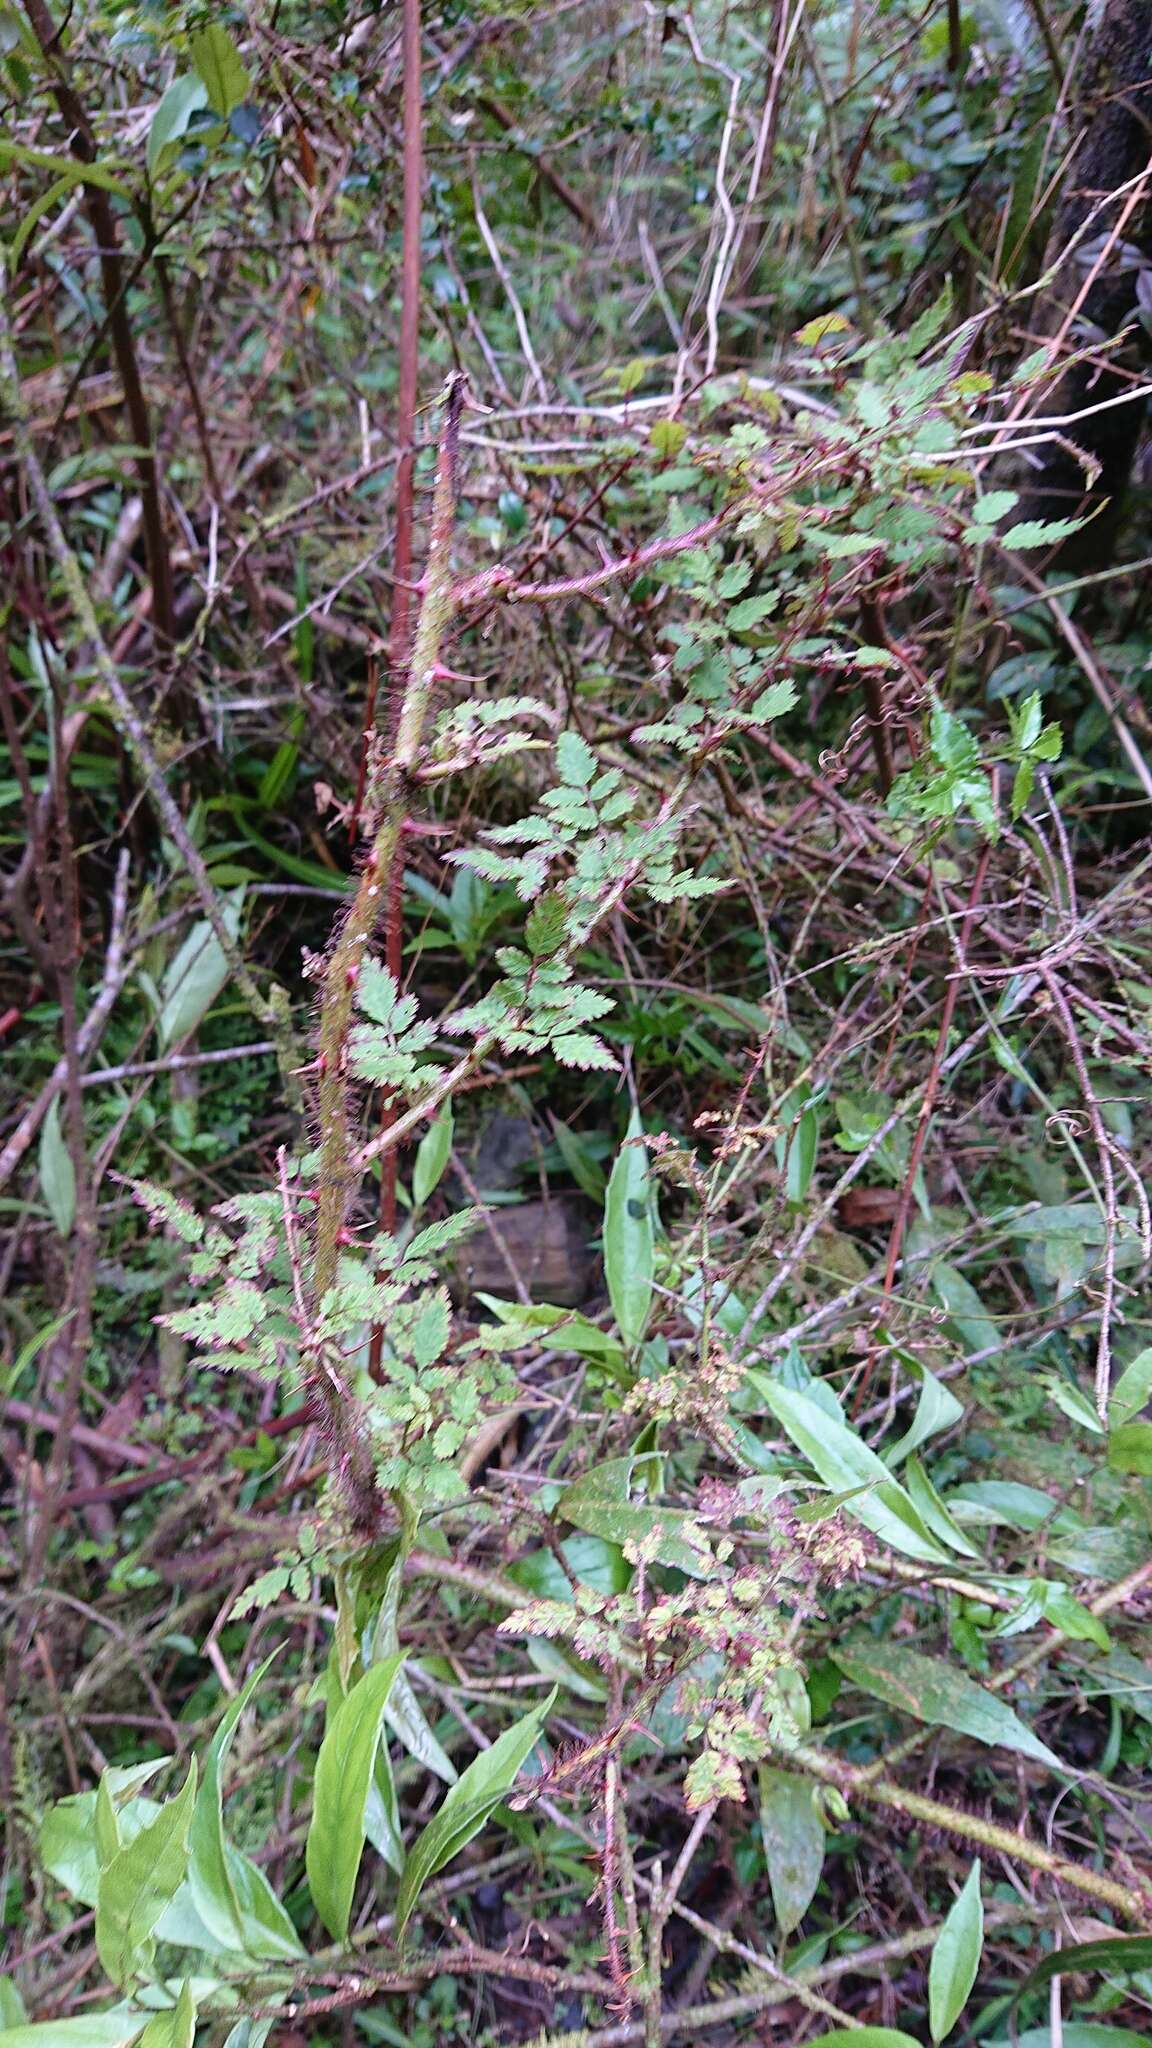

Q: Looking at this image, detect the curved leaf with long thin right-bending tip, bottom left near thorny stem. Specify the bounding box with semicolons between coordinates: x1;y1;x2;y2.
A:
189;1651;303;1962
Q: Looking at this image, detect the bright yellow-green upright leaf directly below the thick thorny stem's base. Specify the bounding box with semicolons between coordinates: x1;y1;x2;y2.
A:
305;1655;403;1942
